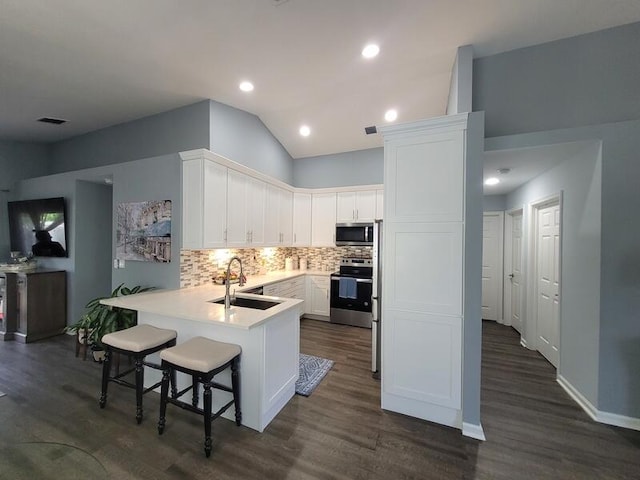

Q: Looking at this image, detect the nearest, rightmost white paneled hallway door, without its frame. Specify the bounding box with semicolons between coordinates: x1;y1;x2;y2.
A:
536;204;560;368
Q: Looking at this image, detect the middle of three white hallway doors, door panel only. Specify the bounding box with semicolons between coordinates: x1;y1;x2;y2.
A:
505;210;523;333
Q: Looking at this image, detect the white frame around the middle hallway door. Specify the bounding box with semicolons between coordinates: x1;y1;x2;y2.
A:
502;205;527;335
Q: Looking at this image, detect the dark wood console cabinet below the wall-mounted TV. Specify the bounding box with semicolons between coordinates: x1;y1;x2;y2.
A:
0;269;67;343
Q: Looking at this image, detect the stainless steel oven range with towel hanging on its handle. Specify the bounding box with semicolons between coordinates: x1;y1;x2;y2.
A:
330;258;373;328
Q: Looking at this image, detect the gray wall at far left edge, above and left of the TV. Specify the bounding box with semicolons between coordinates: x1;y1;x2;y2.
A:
0;142;50;261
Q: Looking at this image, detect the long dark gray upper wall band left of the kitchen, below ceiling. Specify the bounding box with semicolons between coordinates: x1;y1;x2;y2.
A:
51;100;209;173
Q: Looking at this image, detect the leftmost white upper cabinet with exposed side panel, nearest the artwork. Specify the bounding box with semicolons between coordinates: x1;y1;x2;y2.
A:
182;158;227;249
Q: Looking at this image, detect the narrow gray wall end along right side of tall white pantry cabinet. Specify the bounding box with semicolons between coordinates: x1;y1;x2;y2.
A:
462;112;484;425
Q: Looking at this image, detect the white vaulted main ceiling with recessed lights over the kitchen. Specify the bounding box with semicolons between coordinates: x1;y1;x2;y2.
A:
0;0;640;158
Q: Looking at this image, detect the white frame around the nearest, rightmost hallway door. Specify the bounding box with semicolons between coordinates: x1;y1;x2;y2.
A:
525;190;564;372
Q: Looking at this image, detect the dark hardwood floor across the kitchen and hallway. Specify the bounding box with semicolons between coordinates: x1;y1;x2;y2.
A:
0;320;640;480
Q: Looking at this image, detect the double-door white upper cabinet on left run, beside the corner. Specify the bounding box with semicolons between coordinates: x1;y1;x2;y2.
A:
264;185;293;247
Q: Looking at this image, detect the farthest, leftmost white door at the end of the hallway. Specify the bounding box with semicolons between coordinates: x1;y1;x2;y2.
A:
482;212;504;323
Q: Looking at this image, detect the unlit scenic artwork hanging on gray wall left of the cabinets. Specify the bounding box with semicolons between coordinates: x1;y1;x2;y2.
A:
116;200;171;263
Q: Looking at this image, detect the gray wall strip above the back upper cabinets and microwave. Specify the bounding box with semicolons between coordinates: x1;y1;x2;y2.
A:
293;147;384;188
